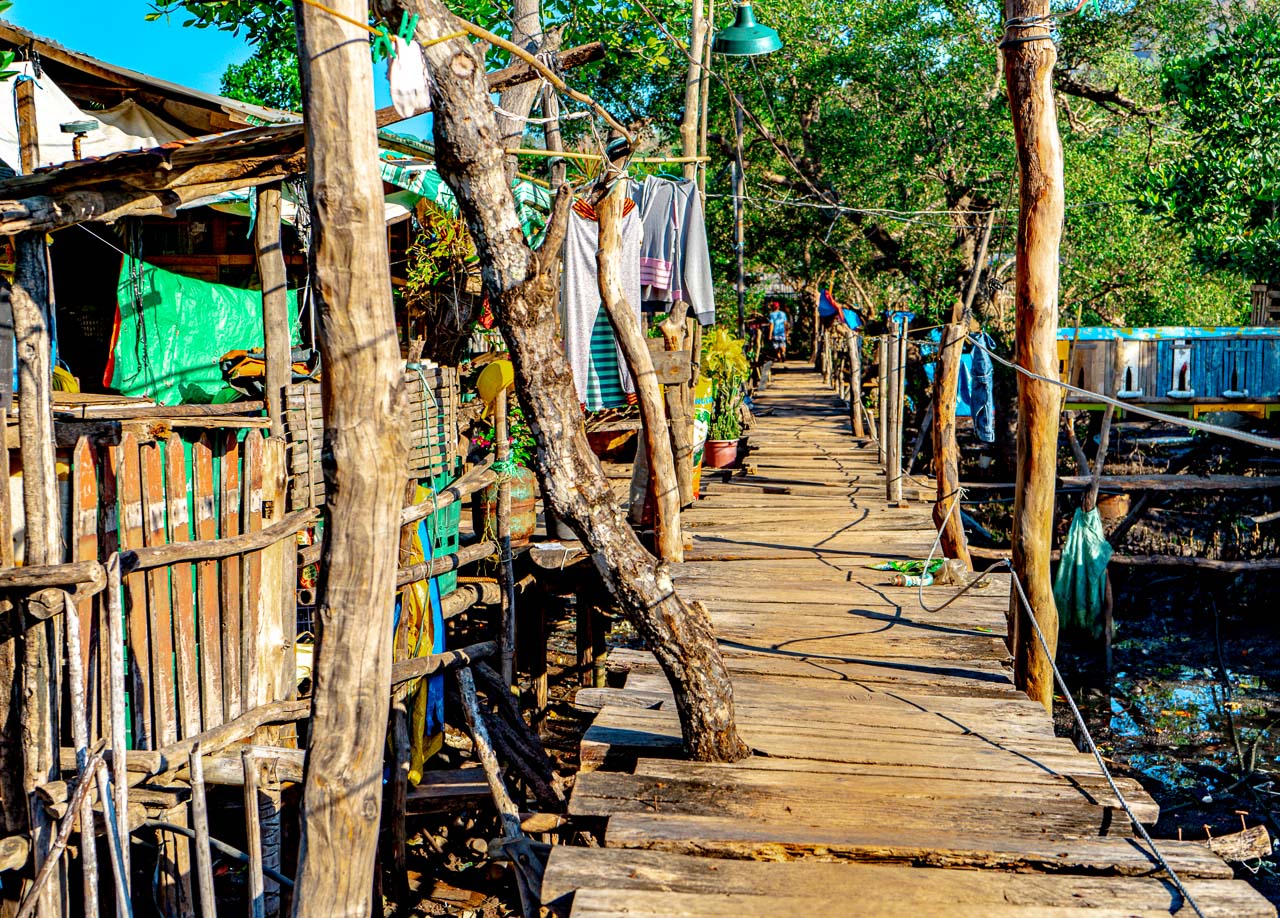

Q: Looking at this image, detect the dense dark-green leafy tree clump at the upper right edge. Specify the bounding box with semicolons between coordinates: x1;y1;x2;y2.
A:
1139;12;1280;282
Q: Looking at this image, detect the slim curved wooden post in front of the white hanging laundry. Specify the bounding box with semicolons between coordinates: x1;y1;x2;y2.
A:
596;182;685;563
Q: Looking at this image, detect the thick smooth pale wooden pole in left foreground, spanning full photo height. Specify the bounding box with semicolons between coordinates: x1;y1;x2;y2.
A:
293;0;407;917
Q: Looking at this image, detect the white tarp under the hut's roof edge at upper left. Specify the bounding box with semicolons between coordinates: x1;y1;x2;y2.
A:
0;61;189;172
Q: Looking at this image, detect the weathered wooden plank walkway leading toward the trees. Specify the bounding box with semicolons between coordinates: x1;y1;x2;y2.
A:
544;369;1275;918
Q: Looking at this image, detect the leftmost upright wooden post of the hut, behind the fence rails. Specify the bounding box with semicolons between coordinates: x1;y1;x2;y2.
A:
10;227;63;915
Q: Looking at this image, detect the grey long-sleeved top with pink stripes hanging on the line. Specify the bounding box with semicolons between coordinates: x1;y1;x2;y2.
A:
632;177;716;325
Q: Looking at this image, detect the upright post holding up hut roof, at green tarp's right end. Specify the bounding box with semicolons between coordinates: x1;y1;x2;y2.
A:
253;182;293;437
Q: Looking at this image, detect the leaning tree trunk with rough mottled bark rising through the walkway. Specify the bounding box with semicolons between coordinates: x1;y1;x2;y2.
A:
403;0;749;762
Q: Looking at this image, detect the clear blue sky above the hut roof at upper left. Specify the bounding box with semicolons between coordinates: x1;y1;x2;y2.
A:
5;0;430;134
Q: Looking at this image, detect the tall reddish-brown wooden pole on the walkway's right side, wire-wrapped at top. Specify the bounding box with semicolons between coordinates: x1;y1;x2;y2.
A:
1005;0;1064;709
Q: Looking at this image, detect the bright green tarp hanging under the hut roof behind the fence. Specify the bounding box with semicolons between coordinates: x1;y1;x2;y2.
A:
104;257;298;405
